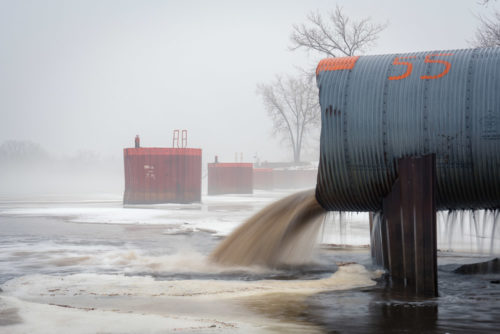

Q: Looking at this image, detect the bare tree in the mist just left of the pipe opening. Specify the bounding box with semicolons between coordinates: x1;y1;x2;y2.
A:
257;75;320;162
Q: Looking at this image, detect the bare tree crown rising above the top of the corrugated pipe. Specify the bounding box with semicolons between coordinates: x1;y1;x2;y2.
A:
290;5;387;57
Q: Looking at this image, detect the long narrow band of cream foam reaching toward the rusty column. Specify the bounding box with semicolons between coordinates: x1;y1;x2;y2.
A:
2;264;379;301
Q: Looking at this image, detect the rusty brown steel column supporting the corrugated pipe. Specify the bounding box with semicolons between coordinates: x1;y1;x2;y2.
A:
373;154;437;297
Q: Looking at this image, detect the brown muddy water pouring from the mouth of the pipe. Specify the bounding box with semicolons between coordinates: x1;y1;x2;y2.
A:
210;189;326;267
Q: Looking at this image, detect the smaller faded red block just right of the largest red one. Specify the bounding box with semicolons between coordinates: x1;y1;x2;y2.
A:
208;162;253;195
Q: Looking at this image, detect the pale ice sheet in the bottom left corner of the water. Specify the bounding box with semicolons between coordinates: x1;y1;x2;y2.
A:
0;297;247;334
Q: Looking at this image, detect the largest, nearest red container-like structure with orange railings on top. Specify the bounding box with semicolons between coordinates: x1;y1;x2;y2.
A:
123;148;201;204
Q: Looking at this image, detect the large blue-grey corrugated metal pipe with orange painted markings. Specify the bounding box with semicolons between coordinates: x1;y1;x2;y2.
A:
316;48;500;211
